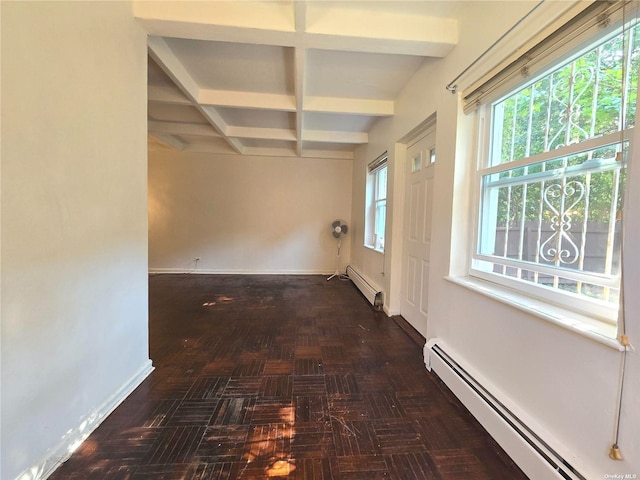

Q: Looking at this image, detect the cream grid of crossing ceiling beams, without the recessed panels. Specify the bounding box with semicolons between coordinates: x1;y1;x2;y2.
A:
141;0;458;159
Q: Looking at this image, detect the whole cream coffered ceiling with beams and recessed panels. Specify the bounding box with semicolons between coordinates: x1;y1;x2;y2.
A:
140;0;458;159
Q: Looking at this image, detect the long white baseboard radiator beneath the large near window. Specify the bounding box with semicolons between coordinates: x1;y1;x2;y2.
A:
425;339;586;480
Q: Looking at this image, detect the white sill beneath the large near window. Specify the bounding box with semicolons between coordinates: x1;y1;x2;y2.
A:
445;277;624;352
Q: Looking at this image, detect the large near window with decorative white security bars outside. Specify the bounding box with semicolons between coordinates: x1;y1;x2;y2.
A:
471;18;640;321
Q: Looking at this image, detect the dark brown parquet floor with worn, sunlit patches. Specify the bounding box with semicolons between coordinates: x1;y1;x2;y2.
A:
51;275;526;480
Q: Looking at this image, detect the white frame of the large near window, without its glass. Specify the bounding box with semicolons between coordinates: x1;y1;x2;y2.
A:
469;18;640;326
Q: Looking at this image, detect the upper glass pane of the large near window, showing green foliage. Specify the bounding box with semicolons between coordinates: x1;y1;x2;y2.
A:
490;26;640;165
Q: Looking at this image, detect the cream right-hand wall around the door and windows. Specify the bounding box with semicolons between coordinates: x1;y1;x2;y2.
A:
351;1;640;479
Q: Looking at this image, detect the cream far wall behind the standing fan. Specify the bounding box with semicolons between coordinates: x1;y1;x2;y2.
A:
149;150;351;274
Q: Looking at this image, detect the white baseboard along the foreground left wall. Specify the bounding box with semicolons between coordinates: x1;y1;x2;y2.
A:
18;360;153;480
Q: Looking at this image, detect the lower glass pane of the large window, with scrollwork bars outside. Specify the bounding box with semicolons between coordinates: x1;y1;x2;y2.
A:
478;142;625;302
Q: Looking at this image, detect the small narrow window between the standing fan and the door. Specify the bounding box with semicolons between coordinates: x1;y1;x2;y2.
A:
364;153;387;252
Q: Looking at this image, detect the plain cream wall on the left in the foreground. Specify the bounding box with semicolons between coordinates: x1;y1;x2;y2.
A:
0;2;150;480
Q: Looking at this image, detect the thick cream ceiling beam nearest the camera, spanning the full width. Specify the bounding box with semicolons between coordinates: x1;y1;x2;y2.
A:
133;0;458;58
